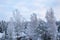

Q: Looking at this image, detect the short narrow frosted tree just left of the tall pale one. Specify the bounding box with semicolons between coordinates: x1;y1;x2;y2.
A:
7;17;14;40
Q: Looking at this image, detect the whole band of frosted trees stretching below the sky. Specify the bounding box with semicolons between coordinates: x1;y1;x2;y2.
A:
0;9;60;40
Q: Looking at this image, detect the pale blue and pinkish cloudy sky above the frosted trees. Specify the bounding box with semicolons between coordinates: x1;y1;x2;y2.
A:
0;0;60;21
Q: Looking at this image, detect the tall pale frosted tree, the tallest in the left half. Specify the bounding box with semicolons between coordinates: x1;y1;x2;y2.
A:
13;9;24;37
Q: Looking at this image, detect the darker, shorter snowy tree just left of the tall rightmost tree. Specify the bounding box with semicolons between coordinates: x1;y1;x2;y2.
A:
35;19;47;40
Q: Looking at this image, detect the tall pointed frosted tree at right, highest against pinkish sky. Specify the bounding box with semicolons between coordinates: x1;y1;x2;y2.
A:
46;8;57;40
